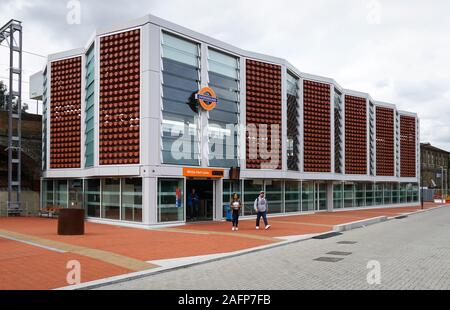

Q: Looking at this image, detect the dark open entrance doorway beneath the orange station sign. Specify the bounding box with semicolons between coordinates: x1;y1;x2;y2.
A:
186;180;214;222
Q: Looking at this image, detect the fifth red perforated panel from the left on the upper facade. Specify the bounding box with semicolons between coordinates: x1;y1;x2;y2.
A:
345;95;367;174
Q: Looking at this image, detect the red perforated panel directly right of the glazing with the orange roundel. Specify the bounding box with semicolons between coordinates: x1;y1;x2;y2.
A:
246;60;281;169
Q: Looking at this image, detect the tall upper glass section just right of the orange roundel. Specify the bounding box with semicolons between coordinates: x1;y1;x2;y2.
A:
208;49;240;168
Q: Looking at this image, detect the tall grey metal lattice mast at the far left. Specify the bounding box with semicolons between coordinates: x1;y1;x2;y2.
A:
0;19;22;216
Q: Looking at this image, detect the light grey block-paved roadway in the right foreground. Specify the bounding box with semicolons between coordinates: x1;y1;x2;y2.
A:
98;203;450;294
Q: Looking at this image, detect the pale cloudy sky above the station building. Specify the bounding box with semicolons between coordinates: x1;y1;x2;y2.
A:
0;0;450;150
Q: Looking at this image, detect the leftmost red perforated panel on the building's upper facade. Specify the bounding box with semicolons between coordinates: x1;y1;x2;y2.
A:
50;57;81;169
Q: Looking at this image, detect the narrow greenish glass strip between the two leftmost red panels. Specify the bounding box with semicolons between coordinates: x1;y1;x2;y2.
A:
84;45;95;167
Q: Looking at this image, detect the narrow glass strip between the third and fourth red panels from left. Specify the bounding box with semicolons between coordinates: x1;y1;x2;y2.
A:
287;72;299;171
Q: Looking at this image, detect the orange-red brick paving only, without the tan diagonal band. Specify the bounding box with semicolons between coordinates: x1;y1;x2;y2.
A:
0;204;437;289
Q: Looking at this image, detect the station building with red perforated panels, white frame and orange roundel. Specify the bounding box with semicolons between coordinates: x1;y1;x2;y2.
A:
31;15;420;225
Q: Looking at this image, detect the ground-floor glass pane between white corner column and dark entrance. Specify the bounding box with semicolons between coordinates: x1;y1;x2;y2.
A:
158;179;185;223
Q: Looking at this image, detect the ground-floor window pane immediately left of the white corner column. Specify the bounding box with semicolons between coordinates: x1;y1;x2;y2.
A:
122;178;142;222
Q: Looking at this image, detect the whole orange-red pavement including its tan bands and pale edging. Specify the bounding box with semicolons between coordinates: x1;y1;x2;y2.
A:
0;204;438;290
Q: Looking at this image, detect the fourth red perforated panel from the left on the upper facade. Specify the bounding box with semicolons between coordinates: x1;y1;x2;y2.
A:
303;80;331;172
